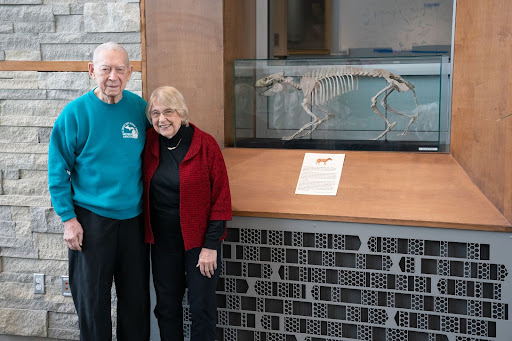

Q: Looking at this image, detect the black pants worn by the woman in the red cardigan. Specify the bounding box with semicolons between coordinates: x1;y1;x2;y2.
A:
151;214;221;341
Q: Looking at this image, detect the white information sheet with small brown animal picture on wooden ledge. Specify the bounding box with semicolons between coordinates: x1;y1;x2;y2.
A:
295;153;345;195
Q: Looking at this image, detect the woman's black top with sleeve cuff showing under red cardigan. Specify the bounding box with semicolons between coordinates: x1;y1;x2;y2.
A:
149;125;225;249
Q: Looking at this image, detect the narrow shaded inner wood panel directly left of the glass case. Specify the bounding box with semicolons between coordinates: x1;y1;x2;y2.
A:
224;0;256;146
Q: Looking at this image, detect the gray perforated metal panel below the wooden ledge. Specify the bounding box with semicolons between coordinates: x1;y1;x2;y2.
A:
178;217;512;341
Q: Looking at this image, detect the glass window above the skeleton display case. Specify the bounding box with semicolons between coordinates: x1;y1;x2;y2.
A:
268;0;453;58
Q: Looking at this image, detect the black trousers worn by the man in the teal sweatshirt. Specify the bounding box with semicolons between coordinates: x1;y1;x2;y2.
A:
69;206;150;341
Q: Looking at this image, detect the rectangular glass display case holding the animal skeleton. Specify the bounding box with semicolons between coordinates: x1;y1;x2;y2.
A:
234;56;451;152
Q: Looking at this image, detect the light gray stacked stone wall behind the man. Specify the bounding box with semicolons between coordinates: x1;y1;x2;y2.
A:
0;0;142;340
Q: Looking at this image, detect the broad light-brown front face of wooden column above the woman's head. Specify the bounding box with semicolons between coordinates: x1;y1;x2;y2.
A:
144;0;224;146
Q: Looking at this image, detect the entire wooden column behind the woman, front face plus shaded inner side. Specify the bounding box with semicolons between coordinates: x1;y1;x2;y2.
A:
144;0;256;147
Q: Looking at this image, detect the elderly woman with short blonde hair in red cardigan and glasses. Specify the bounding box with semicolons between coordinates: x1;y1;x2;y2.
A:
143;86;231;341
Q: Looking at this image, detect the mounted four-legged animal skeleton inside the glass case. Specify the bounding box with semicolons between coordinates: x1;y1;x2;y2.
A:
255;66;419;140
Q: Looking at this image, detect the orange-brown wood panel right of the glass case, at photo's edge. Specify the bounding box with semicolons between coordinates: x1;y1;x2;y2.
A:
451;0;512;221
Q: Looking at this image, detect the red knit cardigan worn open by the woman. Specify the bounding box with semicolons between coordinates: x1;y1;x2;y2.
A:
143;124;231;250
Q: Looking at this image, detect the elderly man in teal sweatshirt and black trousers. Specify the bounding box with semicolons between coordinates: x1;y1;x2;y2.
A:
48;42;149;341
